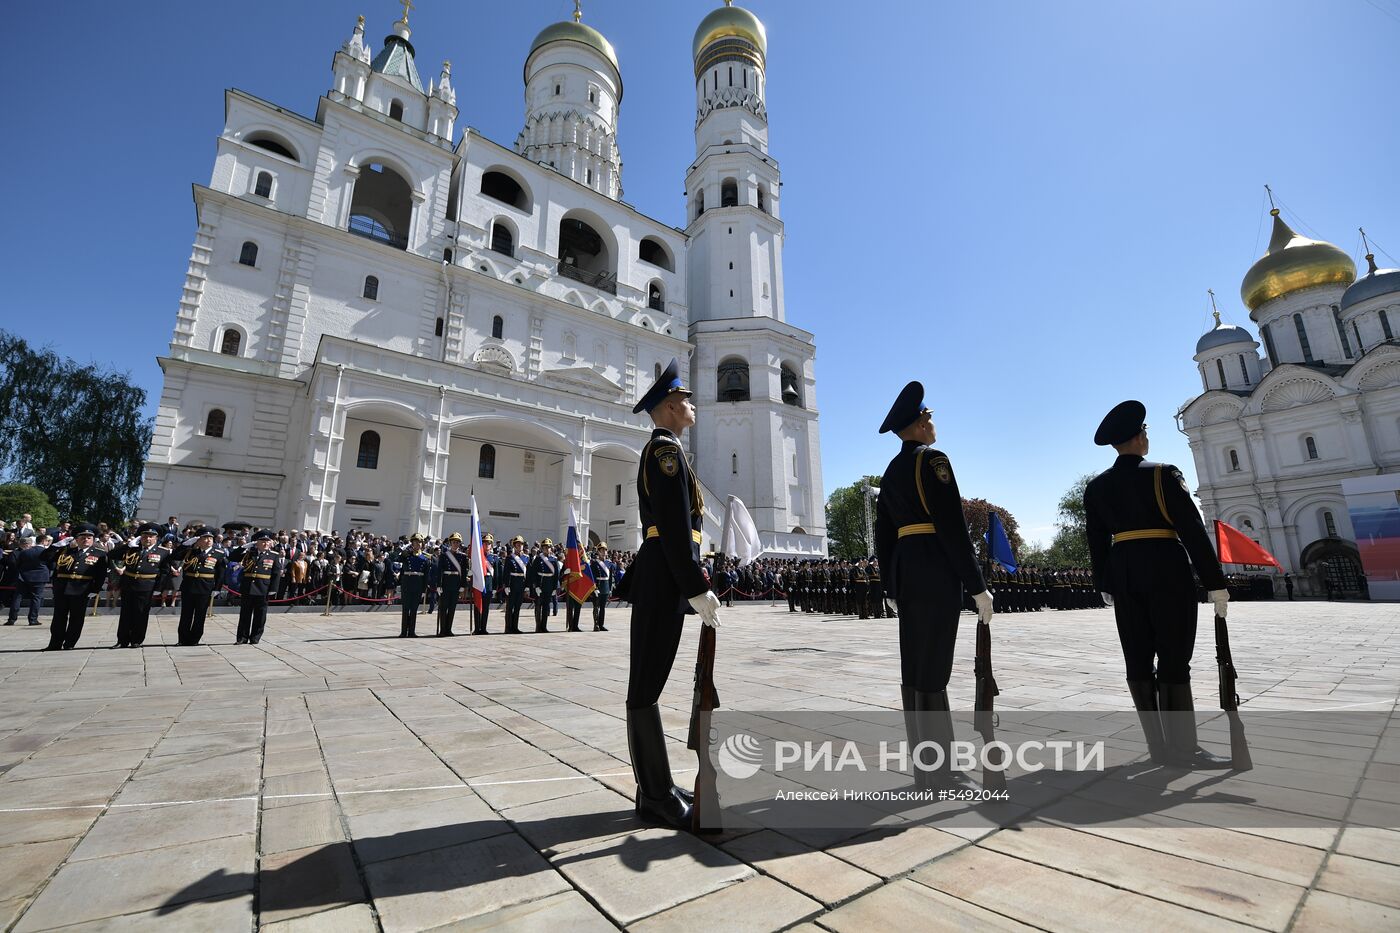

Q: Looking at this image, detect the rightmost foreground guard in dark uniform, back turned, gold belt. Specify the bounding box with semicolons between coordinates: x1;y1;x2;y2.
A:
1084;399;1231;768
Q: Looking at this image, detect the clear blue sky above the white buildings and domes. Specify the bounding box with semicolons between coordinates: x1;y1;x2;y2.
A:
0;0;1400;539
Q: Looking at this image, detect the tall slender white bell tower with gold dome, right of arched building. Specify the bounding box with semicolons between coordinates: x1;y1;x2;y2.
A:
686;3;826;553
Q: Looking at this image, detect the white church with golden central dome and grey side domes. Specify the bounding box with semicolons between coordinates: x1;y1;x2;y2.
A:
1177;209;1400;597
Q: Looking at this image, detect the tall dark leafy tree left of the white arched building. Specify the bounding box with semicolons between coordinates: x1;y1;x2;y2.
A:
0;331;151;523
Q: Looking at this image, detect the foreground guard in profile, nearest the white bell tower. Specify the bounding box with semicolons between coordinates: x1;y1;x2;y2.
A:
626;360;720;829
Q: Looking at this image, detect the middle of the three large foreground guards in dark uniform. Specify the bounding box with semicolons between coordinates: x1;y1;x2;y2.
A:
875;382;993;790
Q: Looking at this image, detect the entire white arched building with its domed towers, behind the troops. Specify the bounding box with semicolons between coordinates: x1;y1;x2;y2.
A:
140;6;826;556
